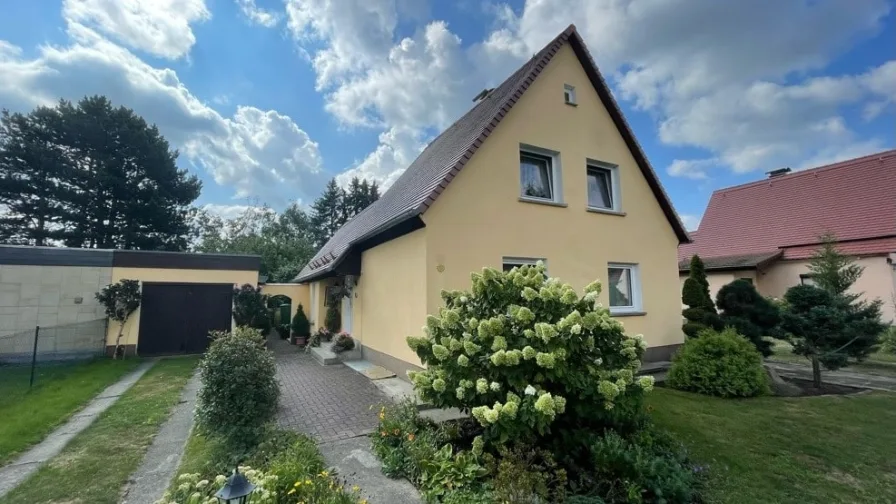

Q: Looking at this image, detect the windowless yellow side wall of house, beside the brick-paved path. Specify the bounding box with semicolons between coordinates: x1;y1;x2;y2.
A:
352;229;428;371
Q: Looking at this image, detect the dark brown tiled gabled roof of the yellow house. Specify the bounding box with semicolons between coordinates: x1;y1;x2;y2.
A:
295;25;689;282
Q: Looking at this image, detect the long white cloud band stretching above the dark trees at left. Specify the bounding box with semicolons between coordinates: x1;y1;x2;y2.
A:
0;24;324;206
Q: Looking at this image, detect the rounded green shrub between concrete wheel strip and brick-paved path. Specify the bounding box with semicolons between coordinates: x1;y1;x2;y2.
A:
196;328;280;445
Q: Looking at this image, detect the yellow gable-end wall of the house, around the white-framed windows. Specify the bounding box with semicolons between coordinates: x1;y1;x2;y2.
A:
424;46;684;346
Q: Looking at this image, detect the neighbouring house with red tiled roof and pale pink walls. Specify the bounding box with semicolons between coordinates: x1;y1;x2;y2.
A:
678;150;896;321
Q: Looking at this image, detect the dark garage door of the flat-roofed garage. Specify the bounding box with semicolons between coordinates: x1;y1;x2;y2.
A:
137;282;233;356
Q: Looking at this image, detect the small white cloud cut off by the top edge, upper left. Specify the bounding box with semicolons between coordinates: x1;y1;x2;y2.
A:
62;0;211;59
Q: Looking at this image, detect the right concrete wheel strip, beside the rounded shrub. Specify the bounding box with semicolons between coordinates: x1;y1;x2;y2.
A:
121;372;201;504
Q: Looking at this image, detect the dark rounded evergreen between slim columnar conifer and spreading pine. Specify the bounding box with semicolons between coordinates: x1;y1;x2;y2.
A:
716;278;781;357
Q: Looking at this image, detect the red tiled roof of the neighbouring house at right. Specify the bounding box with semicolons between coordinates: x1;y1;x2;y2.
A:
678;150;896;268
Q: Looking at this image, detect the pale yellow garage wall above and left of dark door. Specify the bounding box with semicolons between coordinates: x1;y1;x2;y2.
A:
106;267;258;352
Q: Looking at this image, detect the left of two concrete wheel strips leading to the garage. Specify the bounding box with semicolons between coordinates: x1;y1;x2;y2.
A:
0;361;155;498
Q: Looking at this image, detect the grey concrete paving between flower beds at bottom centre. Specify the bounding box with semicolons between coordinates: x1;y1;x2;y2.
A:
320;436;423;504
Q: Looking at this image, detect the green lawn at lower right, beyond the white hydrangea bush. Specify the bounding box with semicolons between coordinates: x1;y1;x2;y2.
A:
649;389;896;504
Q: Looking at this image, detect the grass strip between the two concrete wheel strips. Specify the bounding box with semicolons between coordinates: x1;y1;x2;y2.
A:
2;358;196;504
